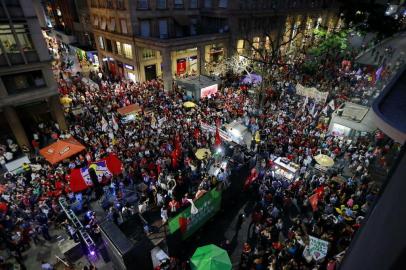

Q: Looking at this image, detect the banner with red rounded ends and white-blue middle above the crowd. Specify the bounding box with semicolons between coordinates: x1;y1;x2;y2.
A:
69;153;122;192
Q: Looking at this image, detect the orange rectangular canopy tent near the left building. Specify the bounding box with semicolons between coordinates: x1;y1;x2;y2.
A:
39;137;85;164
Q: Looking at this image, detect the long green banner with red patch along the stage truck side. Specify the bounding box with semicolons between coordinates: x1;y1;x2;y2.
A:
168;189;221;239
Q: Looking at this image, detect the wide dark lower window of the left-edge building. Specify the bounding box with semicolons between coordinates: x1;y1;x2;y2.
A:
1;70;46;95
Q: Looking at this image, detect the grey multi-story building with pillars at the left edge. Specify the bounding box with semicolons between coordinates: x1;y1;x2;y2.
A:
0;0;66;147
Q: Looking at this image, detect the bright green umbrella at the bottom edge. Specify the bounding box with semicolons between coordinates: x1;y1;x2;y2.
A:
190;245;231;270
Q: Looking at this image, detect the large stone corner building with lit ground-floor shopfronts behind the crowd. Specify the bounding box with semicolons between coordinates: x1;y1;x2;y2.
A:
88;0;339;89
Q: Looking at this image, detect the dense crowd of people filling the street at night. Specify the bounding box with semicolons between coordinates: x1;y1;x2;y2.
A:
0;31;402;269
